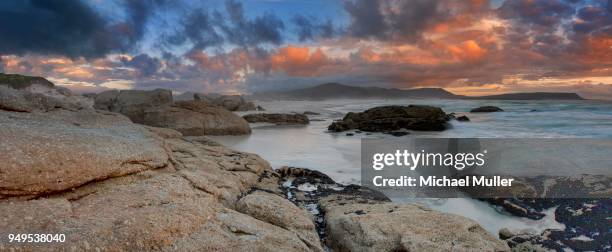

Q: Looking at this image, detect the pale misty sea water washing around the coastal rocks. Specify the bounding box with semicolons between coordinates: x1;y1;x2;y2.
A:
211;99;612;234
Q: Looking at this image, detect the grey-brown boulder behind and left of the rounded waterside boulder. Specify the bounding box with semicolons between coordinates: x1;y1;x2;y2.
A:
94;89;172;123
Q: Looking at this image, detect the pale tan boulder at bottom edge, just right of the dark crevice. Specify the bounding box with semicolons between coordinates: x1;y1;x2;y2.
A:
323;203;509;251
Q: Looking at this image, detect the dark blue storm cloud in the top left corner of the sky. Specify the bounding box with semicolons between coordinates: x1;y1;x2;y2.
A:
0;0;161;58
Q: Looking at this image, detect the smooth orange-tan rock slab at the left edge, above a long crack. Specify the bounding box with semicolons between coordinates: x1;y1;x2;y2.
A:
0;104;169;198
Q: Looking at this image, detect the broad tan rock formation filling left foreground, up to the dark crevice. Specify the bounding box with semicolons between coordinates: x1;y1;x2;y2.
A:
0;88;322;251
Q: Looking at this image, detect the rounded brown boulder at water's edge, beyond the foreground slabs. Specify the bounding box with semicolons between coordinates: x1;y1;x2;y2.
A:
141;101;251;136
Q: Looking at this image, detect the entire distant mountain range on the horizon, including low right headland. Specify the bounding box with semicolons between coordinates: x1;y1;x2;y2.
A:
252;83;583;100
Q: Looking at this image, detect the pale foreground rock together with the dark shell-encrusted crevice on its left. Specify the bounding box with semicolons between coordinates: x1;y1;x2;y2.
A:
277;167;510;251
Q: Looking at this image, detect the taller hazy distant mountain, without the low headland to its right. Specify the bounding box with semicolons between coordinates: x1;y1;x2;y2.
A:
254;83;460;100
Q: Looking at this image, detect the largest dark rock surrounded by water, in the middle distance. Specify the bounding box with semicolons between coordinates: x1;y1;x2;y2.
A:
328;105;448;132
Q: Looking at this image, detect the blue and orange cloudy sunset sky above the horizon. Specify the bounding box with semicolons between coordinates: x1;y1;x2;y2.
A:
0;0;612;99
